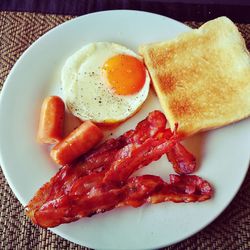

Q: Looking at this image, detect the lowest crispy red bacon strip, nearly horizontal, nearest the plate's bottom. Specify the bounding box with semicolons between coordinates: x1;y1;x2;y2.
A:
27;175;213;227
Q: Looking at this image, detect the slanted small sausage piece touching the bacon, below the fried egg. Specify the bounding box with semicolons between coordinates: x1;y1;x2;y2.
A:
50;121;103;165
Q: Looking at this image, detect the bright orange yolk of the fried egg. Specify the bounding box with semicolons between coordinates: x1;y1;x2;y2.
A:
103;55;146;95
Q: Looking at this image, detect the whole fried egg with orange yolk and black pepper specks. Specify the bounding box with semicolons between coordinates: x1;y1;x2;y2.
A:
62;42;150;124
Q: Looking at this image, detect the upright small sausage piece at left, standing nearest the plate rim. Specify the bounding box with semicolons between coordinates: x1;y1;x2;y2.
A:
37;96;65;144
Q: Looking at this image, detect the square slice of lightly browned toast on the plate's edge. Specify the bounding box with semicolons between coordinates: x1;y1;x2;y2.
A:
139;17;250;136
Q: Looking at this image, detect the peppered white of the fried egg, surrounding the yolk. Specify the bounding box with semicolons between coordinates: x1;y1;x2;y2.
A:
61;42;150;123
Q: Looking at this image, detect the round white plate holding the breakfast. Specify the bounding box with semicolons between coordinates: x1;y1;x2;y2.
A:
0;10;250;249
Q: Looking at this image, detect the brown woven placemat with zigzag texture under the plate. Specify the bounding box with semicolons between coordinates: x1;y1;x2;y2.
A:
0;12;250;250
